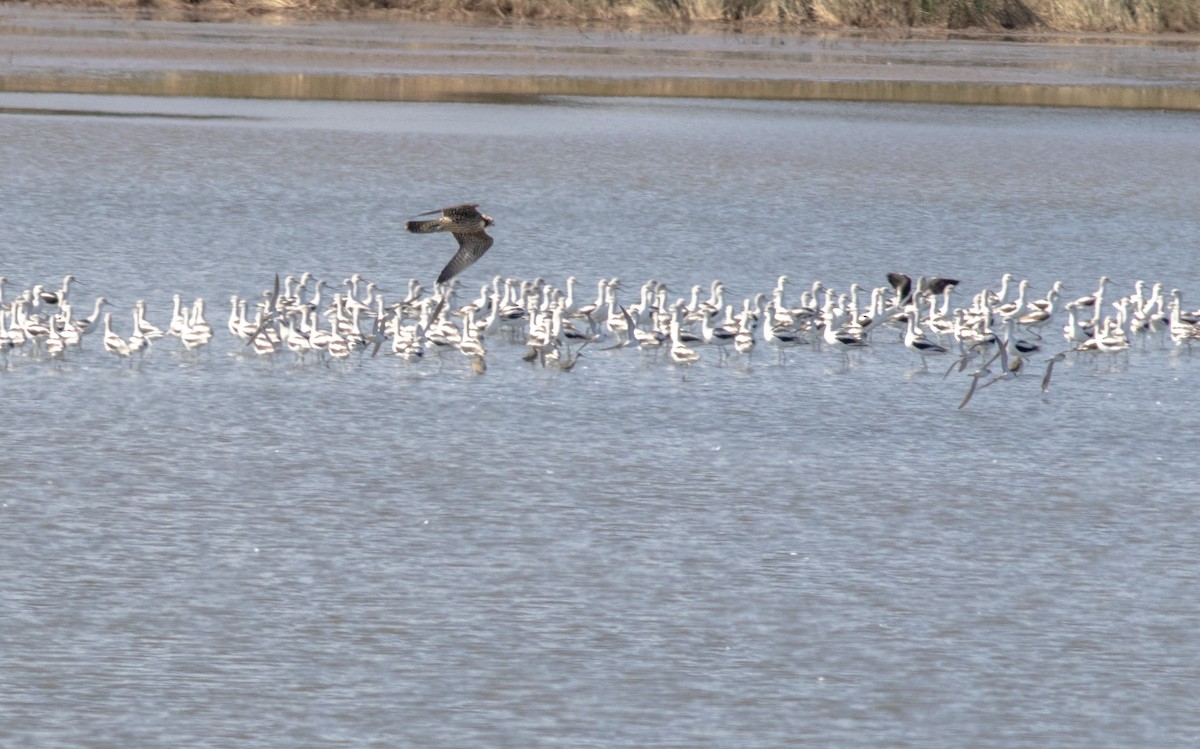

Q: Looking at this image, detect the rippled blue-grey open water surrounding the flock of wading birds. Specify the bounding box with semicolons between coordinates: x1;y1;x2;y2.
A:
0;89;1200;749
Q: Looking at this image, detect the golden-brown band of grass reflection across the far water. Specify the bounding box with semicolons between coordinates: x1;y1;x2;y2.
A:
0;71;1200;110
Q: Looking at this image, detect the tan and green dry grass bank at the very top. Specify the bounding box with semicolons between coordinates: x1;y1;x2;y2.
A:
9;0;1200;34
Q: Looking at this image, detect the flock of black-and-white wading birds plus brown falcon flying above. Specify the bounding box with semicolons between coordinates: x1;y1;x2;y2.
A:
0;203;1200;408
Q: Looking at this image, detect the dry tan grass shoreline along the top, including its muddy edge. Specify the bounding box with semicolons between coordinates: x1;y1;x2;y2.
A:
7;0;1200;38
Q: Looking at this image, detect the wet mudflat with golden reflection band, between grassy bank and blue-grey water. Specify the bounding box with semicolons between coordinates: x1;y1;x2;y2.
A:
0;6;1200;109
